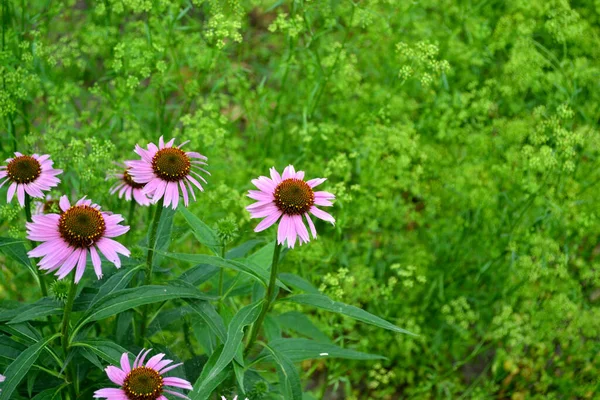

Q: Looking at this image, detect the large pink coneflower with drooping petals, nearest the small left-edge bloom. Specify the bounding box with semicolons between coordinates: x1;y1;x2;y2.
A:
26;196;130;283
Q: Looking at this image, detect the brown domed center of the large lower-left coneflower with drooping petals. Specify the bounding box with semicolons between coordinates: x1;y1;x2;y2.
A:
58;205;106;248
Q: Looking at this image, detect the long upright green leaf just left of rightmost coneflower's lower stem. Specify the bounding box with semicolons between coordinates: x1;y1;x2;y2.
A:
189;300;263;400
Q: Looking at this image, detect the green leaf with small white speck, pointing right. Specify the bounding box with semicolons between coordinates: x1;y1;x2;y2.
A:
262;338;385;362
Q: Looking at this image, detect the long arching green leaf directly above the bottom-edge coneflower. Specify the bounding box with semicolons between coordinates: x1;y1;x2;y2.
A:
73;283;214;337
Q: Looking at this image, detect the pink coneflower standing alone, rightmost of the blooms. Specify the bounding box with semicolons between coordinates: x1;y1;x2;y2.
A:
246;165;335;248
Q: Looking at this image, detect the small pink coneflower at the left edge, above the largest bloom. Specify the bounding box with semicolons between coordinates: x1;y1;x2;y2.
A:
0;152;62;207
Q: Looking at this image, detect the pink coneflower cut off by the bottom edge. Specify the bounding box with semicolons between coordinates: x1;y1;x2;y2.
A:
94;349;192;400
